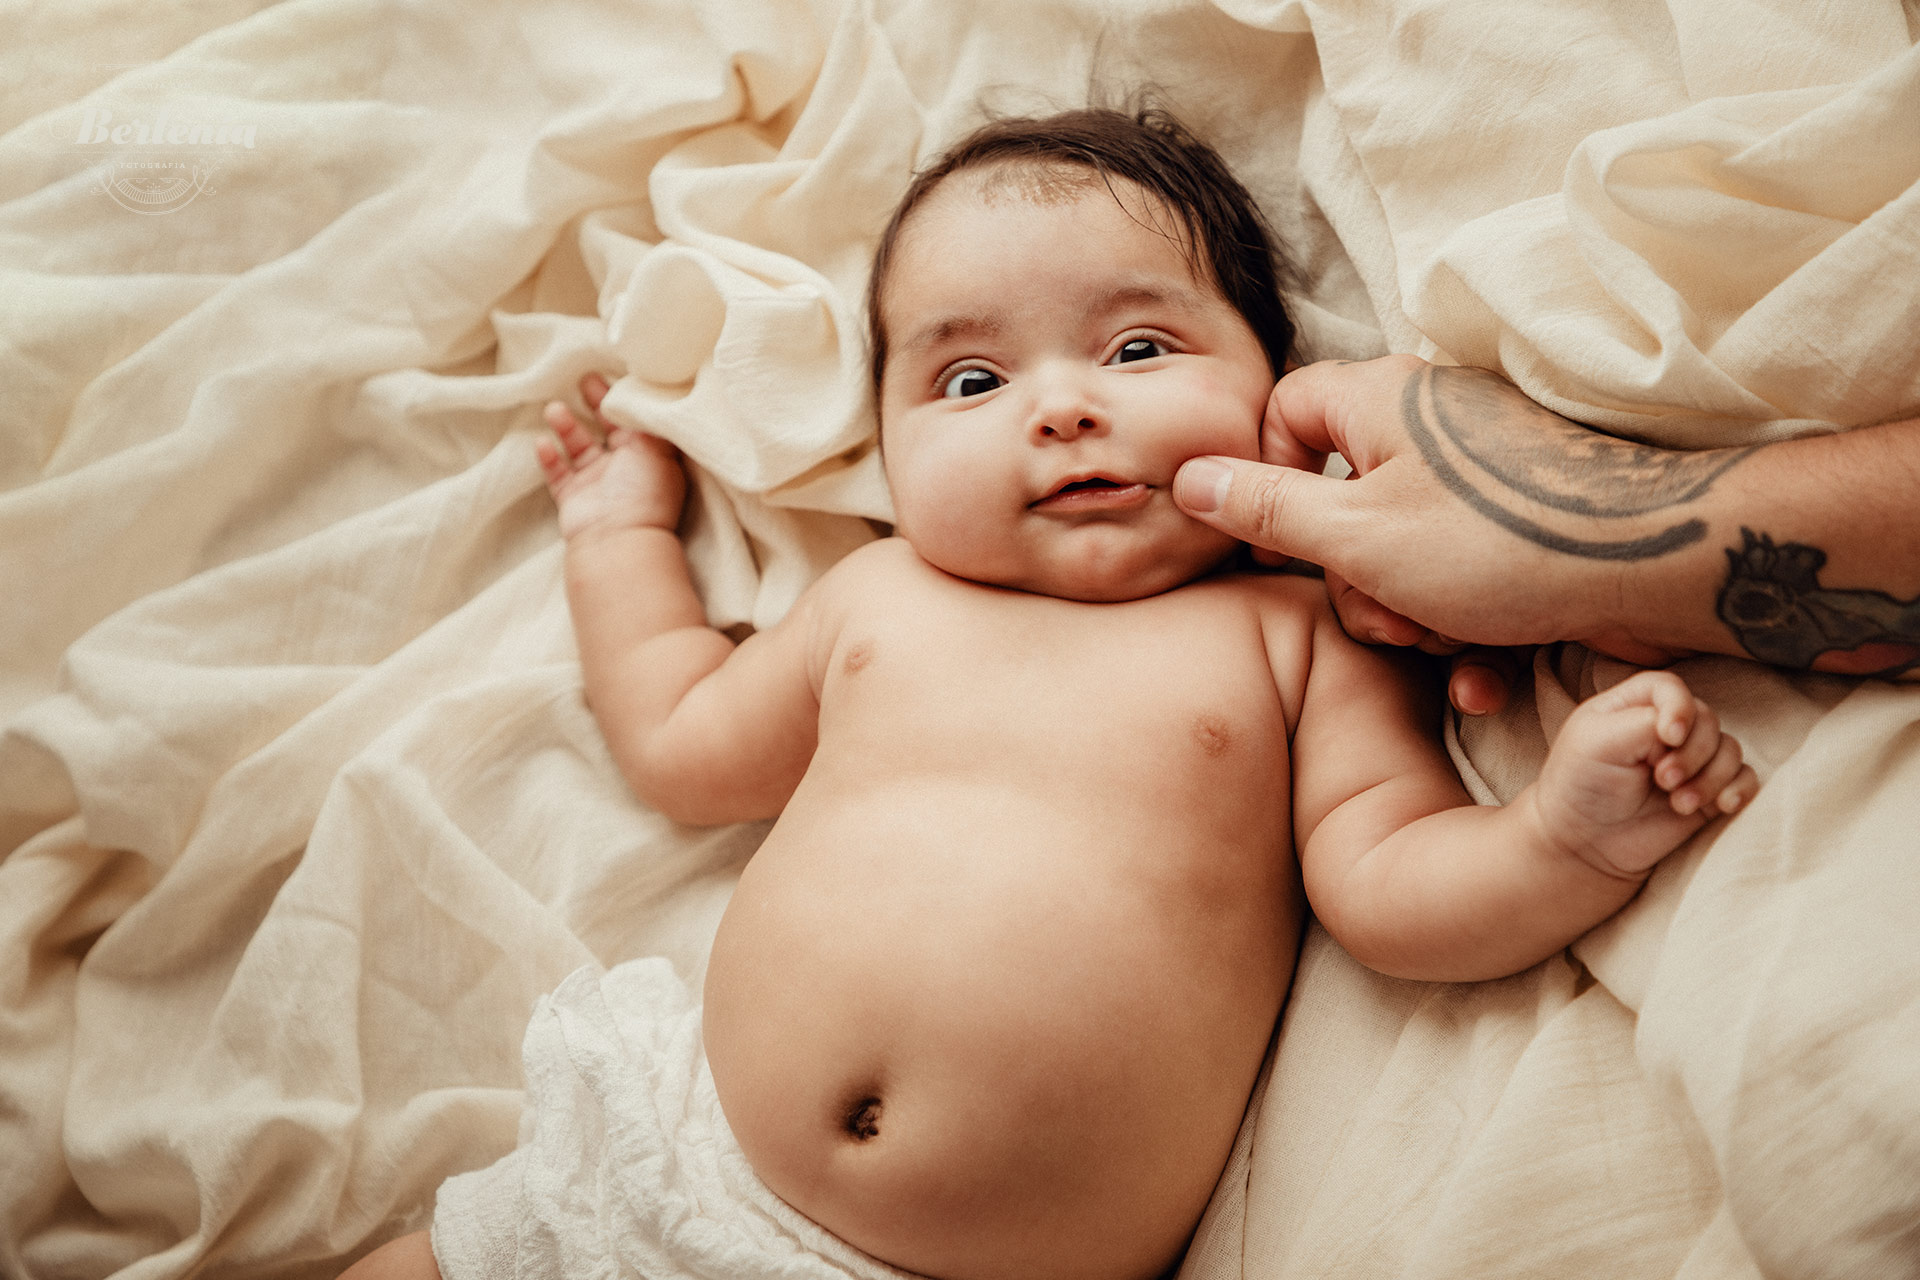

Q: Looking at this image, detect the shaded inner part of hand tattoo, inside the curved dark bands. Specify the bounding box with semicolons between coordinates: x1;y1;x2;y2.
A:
1428;368;1759;516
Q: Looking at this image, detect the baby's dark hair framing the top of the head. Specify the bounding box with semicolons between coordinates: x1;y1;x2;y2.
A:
866;107;1294;390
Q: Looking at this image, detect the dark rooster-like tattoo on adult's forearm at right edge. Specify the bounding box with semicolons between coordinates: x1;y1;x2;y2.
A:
1715;528;1920;676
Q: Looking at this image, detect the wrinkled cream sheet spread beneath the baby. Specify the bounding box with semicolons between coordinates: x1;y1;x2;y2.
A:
0;0;1920;1280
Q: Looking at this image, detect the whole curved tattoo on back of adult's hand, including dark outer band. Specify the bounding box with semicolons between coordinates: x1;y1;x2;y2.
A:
1402;367;1757;560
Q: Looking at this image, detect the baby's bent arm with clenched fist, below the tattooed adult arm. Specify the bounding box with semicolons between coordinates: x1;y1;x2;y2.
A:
1294;610;1759;981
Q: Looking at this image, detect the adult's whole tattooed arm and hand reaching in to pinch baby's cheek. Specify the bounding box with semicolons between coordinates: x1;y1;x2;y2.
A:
1175;357;1920;679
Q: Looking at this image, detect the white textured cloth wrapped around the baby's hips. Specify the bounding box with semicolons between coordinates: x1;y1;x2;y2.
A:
434;958;906;1280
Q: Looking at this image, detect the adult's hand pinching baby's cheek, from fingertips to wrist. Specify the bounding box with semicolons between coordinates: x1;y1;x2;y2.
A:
1173;355;1720;712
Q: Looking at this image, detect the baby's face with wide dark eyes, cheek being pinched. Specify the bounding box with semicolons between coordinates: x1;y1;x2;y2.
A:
879;171;1273;601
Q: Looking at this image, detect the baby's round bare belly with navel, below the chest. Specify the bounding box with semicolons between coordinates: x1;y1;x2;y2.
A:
705;783;1300;1280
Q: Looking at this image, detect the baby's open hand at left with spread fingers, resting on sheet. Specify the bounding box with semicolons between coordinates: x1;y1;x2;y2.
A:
534;374;687;539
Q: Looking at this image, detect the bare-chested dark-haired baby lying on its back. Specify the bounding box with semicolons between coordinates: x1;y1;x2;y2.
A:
341;111;1759;1280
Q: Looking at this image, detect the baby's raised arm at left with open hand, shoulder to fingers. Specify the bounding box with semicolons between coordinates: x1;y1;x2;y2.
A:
538;374;820;823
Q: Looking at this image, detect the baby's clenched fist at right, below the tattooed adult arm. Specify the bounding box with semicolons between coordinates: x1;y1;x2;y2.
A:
1534;672;1761;879
